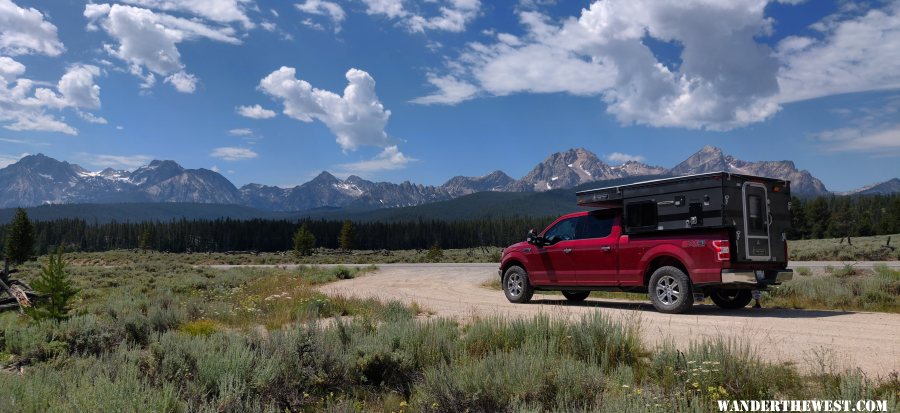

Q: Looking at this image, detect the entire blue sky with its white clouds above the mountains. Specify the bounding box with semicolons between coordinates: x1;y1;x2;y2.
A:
0;0;900;190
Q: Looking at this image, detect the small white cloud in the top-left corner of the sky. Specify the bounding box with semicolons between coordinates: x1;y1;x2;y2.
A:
0;0;65;56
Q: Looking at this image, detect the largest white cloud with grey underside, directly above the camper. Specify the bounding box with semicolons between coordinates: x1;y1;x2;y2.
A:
416;0;779;130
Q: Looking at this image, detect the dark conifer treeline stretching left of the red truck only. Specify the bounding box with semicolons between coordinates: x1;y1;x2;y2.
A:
0;217;552;254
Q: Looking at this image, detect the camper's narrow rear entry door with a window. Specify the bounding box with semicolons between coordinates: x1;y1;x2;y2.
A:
743;182;772;261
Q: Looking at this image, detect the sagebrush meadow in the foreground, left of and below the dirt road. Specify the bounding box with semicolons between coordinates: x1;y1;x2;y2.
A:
0;260;900;413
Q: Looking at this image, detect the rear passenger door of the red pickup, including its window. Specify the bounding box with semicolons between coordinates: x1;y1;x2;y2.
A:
572;211;619;286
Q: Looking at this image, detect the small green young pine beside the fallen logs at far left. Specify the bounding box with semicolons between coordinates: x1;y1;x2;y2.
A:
28;248;78;320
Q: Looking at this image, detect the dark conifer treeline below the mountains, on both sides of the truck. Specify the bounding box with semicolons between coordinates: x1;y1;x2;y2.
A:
0;195;900;254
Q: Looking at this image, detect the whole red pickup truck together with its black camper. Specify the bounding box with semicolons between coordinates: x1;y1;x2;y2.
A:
499;173;792;313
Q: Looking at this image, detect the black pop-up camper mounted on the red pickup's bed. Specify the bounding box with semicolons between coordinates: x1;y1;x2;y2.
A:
576;172;791;262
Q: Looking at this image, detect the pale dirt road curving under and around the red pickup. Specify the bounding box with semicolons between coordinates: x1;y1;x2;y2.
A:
322;263;900;375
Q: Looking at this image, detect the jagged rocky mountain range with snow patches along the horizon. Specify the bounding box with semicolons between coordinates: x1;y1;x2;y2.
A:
0;146;884;211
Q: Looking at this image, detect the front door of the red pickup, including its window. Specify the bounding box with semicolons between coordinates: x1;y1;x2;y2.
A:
529;217;580;285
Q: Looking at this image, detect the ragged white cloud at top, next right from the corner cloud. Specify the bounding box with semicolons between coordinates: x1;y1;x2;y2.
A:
84;1;241;93
